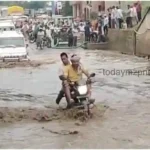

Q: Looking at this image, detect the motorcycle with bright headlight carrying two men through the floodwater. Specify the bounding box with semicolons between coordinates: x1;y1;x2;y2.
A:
60;73;95;115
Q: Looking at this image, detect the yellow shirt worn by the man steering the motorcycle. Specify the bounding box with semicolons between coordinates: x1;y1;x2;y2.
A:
64;65;87;82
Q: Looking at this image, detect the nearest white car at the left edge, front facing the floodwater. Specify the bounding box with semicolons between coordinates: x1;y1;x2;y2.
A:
0;31;28;61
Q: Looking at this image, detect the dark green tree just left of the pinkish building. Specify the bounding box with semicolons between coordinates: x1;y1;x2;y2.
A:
62;1;73;16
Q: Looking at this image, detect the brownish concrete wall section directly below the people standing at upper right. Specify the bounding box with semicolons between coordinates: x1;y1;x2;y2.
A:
108;29;135;54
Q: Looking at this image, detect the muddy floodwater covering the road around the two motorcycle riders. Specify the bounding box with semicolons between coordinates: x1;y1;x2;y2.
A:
0;46;150;148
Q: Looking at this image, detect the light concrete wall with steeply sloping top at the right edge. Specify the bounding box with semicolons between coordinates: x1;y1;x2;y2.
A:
136;11;150;55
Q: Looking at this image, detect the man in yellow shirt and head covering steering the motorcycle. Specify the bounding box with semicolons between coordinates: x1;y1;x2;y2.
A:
59;55;94;108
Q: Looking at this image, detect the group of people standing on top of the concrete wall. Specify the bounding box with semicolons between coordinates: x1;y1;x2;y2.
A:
108;1;142;29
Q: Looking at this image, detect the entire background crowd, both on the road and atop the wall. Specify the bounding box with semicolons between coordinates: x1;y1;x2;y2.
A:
16;2;142;47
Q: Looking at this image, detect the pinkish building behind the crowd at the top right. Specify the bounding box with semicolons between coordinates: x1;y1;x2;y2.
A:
70;1;149;19
